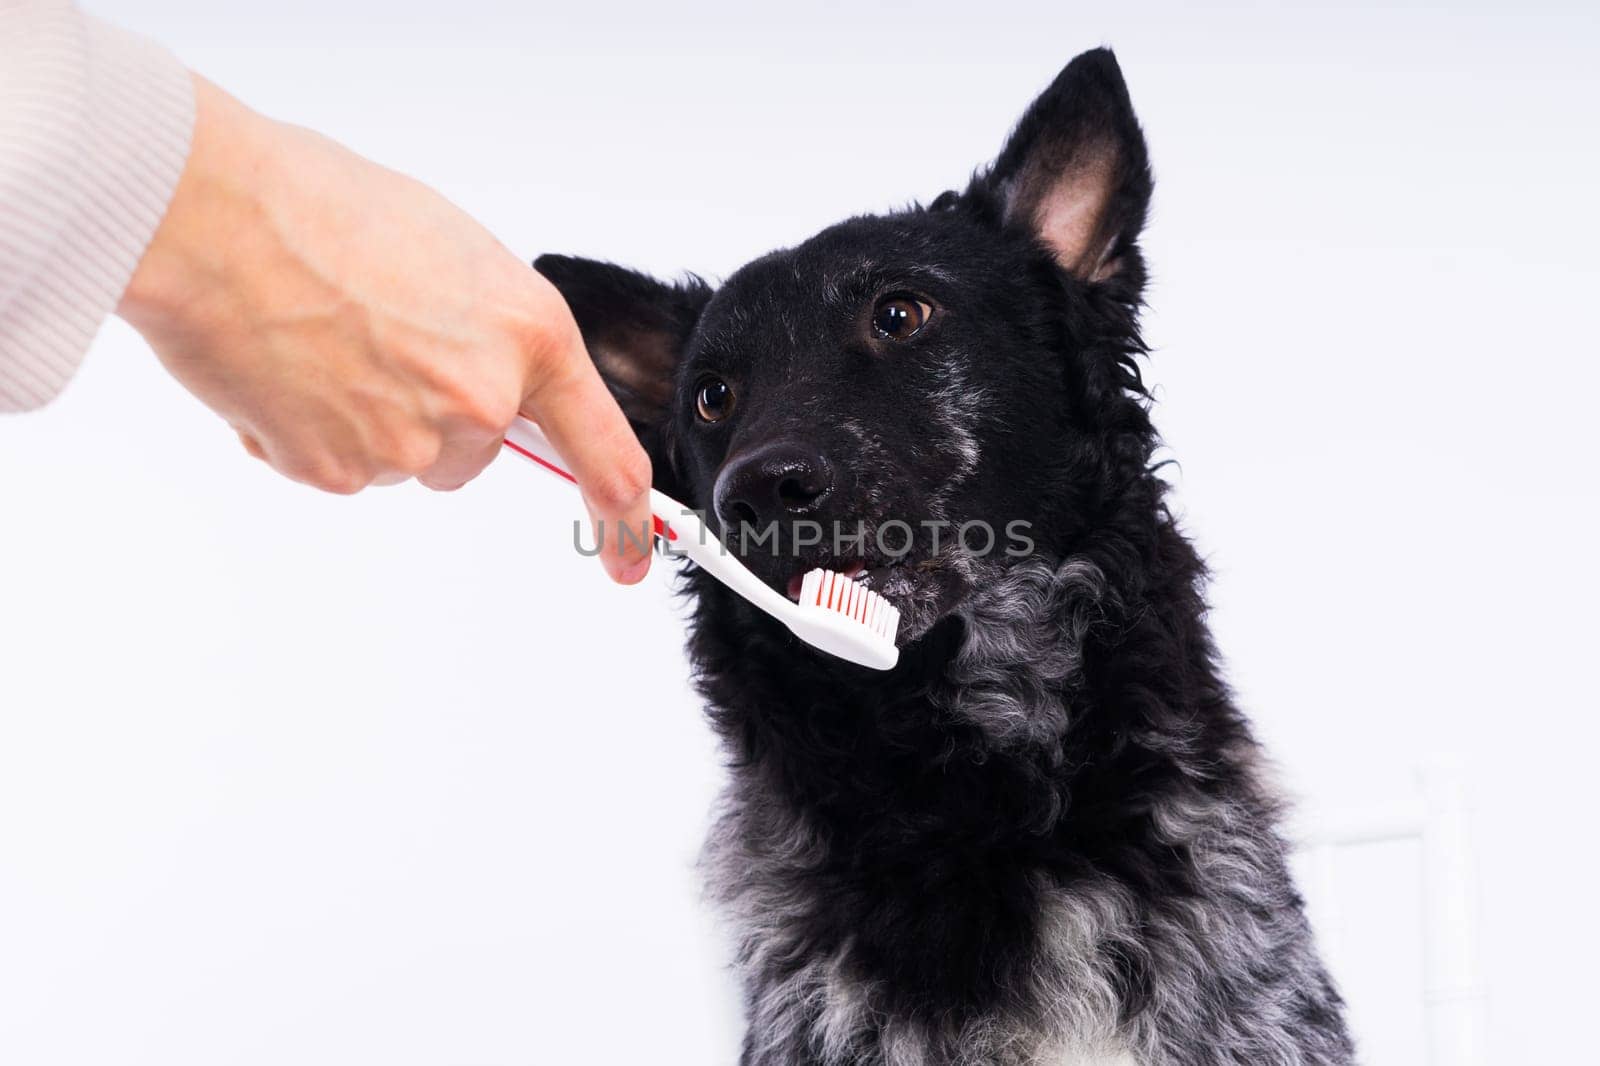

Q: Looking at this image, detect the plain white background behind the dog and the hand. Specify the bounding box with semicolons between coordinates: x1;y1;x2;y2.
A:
0;0;1600;1066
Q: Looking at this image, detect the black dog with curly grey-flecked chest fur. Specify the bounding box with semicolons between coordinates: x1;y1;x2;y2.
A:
534;50;1354;1066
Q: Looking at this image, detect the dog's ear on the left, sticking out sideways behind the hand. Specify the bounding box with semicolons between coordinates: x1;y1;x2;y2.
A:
533;254;710;488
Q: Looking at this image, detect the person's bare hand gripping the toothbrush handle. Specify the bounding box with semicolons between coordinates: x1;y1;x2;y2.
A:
117;77;650;583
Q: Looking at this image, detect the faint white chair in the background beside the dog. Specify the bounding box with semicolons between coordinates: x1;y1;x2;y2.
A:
1293;759;1488;1066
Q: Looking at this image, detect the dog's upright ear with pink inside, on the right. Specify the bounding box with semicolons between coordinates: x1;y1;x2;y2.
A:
981;48;1152;291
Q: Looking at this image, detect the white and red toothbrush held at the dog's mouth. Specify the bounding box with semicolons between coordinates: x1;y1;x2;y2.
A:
506;418;899;671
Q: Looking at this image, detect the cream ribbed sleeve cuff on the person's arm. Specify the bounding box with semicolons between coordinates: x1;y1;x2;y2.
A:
0;0;194;411
